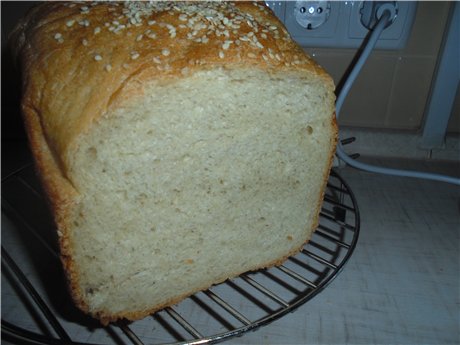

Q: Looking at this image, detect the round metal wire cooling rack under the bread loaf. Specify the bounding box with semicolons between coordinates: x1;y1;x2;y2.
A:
2;165;359;345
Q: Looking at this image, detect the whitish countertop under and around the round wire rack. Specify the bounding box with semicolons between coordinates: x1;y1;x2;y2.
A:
2;144;460;344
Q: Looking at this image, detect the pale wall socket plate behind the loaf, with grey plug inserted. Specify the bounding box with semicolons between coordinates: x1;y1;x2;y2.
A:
266;1;417;49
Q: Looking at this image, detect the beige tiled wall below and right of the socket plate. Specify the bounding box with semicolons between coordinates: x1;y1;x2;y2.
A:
306;1;460;133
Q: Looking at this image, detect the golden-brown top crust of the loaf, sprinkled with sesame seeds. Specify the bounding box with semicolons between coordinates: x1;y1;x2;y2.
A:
13;2;334;170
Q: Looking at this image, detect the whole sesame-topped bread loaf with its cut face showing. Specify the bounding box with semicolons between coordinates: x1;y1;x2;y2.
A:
13;2;337;324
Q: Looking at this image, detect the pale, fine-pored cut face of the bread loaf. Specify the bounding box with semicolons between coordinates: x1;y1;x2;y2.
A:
70;69;331;320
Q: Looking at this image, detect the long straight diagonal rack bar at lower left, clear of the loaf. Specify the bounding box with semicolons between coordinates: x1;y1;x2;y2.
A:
2;246;72;342
